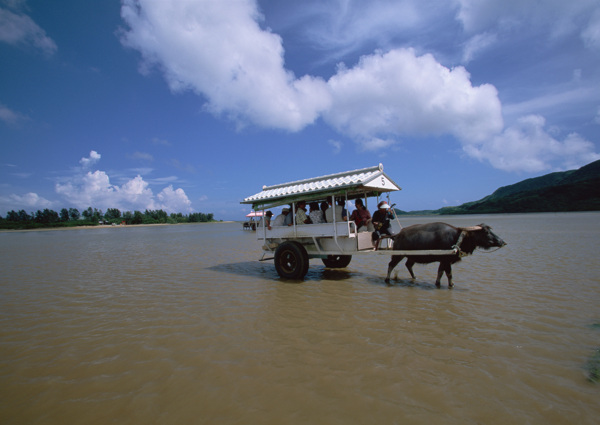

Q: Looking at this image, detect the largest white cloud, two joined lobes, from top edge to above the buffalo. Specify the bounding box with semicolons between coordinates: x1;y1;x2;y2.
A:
121;0;502;143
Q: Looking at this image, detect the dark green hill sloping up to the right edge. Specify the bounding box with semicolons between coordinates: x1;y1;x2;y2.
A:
410;161;600;214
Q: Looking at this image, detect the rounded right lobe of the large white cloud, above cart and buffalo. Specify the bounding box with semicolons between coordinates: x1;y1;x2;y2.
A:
325;49;502;146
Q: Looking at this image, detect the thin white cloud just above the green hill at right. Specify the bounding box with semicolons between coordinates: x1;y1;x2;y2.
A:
463;115;600;173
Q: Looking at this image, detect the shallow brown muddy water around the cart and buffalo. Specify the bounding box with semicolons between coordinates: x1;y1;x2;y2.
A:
0;213;600;424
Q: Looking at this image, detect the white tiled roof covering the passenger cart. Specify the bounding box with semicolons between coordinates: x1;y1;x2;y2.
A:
241;164;400;205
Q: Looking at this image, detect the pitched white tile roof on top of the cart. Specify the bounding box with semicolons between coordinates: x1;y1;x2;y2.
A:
241;164;401;209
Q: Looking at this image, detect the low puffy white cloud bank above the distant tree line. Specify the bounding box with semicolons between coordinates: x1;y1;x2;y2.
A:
55;151;192;213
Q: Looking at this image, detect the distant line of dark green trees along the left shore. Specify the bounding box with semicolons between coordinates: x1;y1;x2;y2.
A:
0;207;215;229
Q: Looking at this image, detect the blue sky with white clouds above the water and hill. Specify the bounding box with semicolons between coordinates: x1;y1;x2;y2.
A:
0;0;600;220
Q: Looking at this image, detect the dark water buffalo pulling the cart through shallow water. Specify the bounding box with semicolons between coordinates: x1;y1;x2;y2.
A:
385;223;506;288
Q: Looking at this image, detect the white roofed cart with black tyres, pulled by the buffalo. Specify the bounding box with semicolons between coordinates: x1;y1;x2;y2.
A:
241;164;459;279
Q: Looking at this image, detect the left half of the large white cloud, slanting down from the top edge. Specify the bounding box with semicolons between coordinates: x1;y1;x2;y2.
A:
121;0;329;131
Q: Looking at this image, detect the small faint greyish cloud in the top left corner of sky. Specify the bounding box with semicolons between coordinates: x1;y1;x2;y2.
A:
0;9;57;55
